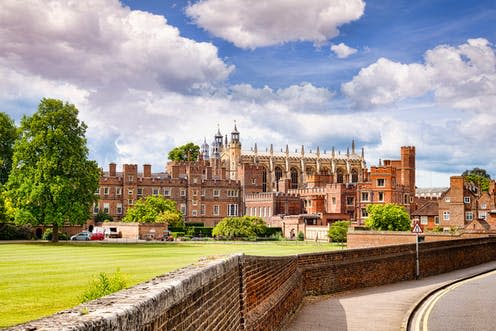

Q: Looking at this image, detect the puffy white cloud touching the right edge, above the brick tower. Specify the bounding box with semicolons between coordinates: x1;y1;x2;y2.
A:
342;38;496;110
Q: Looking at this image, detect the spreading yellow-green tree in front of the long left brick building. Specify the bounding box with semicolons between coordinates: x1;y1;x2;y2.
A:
123;195;183;227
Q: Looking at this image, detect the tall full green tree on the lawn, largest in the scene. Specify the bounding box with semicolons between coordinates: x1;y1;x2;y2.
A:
6;99;100;242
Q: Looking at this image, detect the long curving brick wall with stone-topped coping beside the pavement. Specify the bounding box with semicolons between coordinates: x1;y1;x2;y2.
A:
12;237;496;330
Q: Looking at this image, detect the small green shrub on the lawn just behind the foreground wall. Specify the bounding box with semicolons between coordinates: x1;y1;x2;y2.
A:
80;269;127;303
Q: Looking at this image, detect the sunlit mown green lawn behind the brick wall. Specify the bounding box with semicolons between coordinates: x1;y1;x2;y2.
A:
0;242;336;327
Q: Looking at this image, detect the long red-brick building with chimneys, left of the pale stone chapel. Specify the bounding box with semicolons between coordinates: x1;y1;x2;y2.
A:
93;160;242;226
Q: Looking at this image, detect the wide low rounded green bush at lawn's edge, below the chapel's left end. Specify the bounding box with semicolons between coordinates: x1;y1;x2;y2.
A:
212;216;267;239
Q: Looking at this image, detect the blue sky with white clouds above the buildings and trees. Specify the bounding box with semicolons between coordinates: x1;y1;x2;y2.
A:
0;0;496;187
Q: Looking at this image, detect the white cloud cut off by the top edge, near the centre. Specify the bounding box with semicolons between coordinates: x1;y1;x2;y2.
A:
186;0;365;48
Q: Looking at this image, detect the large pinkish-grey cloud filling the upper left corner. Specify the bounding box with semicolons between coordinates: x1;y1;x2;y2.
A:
0;0;233;90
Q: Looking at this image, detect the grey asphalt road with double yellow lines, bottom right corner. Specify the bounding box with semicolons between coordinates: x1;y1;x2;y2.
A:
411;271;496;331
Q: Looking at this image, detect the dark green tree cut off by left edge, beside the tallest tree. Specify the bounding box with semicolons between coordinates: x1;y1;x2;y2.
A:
0;112;17;186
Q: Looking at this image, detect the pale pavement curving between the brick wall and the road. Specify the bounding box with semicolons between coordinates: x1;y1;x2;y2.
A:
285;261;496;331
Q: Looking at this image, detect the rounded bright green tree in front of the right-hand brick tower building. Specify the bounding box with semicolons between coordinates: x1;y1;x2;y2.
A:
365;203;410;231
